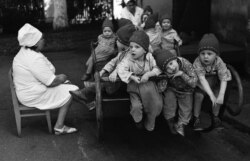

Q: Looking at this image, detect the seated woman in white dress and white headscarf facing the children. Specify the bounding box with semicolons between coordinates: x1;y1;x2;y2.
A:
13;24;78;135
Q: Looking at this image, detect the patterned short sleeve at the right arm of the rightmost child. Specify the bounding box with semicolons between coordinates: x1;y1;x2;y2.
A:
216;57;232;81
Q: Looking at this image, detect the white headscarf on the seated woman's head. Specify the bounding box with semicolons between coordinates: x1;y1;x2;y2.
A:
17;23;43;47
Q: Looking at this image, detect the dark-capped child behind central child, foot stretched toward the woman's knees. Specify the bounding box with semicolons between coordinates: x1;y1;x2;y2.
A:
70;24;135;110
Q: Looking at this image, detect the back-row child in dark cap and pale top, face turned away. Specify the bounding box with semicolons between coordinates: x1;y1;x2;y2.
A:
144;14;161;53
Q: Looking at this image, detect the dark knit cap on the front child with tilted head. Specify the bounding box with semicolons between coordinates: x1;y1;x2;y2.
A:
153;49;177;71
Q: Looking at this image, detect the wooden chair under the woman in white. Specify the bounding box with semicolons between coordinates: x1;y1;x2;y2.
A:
9;68;52;137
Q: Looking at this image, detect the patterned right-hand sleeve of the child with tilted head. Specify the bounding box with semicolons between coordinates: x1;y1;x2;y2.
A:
181;58;198;88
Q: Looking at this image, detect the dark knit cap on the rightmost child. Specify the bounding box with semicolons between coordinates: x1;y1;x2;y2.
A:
198;33;220;55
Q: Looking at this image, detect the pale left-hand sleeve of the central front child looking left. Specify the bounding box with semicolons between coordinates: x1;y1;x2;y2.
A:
117;59;133;83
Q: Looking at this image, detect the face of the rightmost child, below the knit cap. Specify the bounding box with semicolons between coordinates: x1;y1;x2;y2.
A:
199;50;217;65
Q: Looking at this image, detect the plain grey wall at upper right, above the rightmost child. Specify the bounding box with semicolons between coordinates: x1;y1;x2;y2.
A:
211;0;249;46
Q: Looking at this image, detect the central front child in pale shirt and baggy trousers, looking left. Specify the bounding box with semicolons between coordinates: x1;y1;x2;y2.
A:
117;31;162;131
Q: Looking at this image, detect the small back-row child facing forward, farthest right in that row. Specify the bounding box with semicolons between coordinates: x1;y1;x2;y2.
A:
160;14;182;55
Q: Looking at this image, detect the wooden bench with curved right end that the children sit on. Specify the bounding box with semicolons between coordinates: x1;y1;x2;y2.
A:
91;42;244;141
